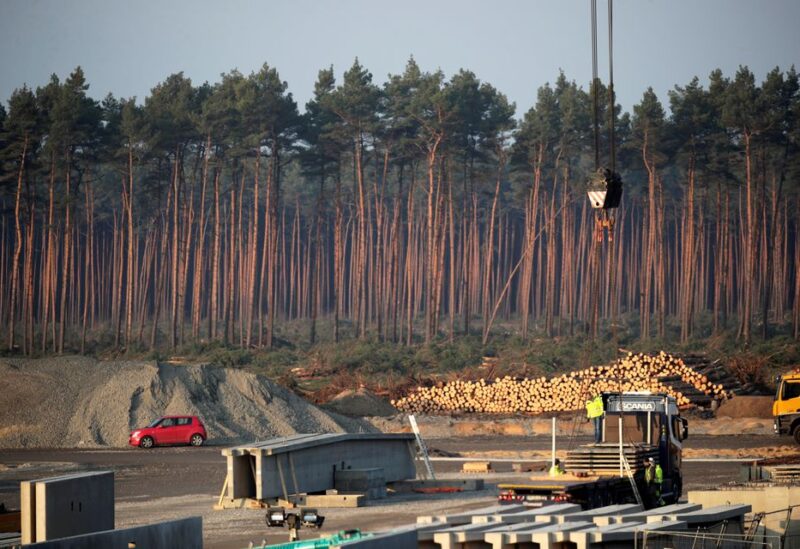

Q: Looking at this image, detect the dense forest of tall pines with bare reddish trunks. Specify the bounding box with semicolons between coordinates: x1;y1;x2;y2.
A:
0;59;800;355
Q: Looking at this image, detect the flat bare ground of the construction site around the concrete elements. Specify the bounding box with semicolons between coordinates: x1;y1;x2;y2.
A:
0;434;799;548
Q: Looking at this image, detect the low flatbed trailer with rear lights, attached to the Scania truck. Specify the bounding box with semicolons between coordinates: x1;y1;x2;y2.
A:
497;475;641;509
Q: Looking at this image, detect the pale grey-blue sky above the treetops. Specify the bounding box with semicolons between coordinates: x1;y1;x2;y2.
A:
0;0;800;117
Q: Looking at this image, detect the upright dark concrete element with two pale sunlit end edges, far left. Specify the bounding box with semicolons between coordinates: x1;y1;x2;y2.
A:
20;471;114;544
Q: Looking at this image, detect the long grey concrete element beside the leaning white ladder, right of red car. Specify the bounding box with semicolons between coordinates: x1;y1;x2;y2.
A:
222;433;416;500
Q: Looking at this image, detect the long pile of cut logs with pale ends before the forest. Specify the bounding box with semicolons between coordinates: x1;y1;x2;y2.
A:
392;351;728;414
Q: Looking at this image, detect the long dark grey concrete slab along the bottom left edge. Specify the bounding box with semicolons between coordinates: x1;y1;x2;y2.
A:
26;517;203;549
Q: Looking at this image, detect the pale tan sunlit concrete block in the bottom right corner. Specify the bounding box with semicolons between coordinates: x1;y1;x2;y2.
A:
688;484;800;547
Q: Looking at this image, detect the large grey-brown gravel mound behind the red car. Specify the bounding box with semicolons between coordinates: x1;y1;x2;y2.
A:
0;357;375;448
